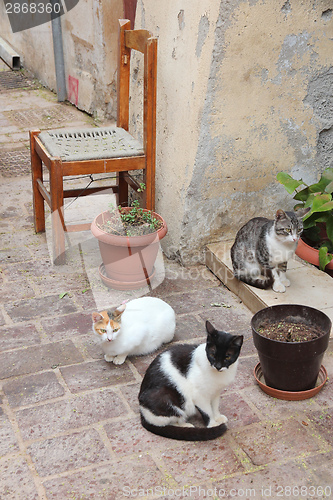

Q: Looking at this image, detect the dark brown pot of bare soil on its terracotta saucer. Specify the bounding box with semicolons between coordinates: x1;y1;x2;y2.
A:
251;304;332;400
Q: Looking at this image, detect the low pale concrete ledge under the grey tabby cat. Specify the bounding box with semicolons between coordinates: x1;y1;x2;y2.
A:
206;241;333;337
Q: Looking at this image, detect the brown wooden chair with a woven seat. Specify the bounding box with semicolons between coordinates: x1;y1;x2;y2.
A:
30;19;157;264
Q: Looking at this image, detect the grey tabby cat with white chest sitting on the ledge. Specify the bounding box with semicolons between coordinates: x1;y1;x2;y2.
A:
231;208;309;292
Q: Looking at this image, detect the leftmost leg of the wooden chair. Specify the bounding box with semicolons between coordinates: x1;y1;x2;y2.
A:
30;130;45;233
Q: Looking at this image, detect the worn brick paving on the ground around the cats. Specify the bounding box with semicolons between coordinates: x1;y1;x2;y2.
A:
0;70;333;500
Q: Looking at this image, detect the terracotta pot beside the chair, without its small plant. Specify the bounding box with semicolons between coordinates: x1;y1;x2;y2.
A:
91;212;168;290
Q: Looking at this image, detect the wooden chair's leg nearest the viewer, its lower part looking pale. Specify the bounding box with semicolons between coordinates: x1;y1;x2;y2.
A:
50;158;66;265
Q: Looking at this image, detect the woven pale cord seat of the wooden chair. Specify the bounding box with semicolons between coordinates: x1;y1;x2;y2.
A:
38;127;144;161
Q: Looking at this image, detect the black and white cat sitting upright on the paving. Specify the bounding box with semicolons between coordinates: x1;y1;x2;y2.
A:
139;321;243;441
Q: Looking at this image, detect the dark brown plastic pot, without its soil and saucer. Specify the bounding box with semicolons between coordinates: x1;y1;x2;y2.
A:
251;304;332;391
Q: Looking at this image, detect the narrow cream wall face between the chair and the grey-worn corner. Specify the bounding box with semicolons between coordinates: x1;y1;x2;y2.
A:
131;0;220;258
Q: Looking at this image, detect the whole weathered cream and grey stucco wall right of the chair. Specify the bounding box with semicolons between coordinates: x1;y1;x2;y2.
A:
136;0;333;261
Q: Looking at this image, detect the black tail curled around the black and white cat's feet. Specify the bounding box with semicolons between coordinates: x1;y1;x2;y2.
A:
141;413;227;441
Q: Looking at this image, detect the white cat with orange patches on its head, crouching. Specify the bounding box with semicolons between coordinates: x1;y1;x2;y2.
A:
92;297;176;365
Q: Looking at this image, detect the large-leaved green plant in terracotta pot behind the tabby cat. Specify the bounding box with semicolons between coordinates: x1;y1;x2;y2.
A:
277;167;333;271
